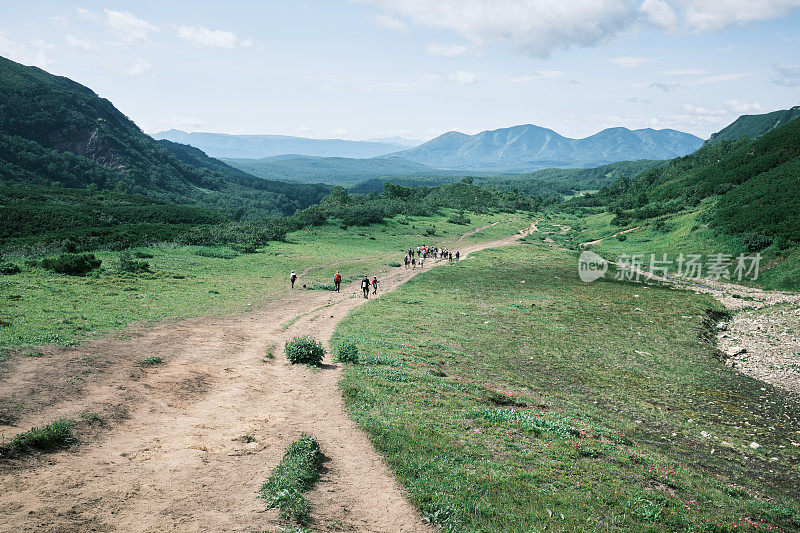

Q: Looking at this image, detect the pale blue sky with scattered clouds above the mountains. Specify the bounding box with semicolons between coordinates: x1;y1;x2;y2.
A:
0;0;800;140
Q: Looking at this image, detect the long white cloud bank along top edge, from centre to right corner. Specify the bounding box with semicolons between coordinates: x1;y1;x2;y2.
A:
364;0;800;57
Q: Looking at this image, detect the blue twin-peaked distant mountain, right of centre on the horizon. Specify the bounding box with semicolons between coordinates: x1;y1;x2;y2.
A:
392;124;703;172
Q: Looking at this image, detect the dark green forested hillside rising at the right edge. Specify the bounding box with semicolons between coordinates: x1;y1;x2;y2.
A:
568;119;800;247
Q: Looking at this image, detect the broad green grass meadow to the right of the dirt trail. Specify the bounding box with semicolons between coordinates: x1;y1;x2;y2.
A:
331;244;800;532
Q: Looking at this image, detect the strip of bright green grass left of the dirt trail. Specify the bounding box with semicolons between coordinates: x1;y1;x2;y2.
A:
0;210;527;348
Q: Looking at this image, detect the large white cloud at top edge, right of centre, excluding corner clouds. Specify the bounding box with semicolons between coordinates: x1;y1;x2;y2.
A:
364;0;638;57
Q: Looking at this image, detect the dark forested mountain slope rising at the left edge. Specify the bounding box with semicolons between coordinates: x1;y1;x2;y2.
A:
0;54;324;219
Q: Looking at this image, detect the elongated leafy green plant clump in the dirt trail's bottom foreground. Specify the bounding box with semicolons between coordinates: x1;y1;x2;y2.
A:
261;434;323;525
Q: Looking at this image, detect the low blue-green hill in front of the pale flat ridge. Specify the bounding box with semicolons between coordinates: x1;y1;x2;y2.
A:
223;155;434;185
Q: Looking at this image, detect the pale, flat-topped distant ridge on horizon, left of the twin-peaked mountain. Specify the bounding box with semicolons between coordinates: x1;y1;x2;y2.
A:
153;130;407;159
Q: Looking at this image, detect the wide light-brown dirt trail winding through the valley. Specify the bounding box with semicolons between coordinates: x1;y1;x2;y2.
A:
0;218;527;533
